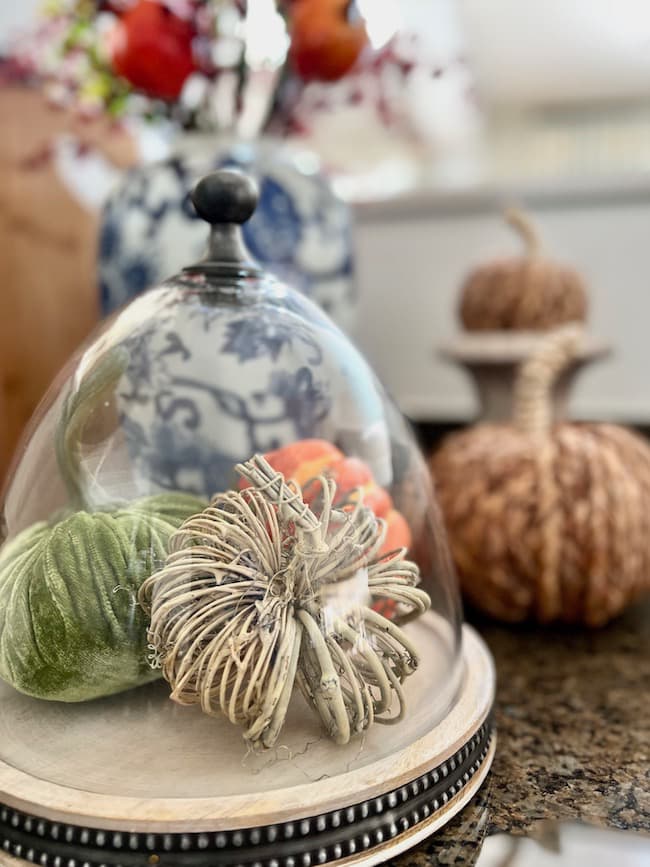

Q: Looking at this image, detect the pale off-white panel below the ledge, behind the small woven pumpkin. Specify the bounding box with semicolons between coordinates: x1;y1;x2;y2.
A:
355;186;650;424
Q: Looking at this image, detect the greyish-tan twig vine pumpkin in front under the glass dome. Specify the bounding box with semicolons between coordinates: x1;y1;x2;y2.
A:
140;455;430;747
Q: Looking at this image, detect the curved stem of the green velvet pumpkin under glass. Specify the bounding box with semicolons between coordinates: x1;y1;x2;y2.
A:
55;348;129;511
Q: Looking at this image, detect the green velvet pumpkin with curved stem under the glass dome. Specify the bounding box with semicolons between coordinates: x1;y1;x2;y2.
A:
0;351;205;702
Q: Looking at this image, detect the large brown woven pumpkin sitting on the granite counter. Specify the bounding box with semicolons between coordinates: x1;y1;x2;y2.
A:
431;327;650;626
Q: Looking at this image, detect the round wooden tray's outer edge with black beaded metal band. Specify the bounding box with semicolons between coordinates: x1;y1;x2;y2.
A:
0;626;496;867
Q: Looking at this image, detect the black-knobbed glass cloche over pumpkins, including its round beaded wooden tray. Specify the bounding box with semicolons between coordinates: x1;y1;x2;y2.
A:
0;171;493;867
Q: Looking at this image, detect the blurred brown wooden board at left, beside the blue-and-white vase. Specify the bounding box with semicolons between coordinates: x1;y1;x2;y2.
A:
0;88;135;476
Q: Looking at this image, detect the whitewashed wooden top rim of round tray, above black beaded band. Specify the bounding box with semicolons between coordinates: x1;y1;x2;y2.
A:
0;624;496;833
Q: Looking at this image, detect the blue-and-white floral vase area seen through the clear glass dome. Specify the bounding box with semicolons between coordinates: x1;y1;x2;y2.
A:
98;276;390;501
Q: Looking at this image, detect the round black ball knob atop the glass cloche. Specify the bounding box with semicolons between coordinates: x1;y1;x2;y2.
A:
192;169;259;226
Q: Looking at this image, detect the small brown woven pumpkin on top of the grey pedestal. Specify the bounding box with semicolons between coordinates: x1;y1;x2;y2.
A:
460;209;588;331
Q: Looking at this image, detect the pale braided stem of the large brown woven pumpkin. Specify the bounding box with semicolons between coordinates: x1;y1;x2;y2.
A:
513;323;584;436
